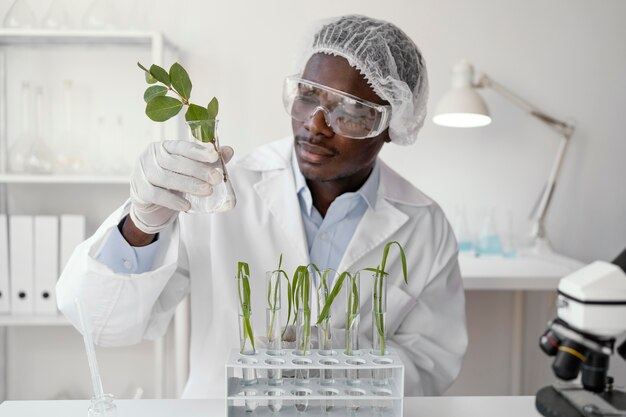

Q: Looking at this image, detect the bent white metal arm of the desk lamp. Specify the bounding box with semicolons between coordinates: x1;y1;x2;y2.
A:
474;74;575;245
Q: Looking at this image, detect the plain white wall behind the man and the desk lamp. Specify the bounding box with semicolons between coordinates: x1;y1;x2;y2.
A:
0;0;626;394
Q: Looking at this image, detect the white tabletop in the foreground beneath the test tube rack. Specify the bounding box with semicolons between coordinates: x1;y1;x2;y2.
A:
0;396;541;417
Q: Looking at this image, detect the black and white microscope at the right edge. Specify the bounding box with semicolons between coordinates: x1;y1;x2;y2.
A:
535;250;626;417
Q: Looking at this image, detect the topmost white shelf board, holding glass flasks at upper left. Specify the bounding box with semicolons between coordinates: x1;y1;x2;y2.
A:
0;29;173;47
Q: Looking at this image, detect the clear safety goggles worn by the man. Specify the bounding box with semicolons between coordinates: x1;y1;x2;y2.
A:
283;76;391;139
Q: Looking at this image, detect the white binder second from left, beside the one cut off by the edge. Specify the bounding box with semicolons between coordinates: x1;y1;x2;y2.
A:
9;215;35;314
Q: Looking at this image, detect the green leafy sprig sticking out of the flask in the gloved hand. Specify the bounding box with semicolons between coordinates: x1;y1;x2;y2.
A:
137;62;219;143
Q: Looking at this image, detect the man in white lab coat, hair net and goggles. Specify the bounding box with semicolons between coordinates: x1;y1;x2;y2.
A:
57;16;467;397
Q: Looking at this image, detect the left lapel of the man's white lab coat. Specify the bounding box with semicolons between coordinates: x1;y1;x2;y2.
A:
254;168;309;263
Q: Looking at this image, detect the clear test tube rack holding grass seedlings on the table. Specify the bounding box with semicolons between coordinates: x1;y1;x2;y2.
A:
226;349;404;417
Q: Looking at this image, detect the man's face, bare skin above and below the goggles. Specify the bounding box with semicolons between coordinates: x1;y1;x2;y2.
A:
292;53;390;181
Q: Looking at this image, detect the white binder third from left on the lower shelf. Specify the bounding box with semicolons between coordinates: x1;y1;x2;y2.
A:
35;216;59;314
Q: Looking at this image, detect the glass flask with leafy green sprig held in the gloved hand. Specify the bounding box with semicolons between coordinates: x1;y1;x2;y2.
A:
137;62;237;213
